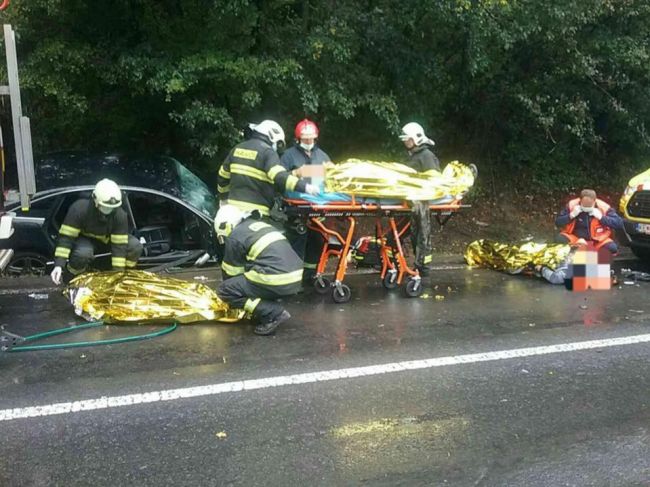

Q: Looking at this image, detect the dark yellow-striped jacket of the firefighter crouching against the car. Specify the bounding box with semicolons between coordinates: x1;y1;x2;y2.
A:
54;199;129;270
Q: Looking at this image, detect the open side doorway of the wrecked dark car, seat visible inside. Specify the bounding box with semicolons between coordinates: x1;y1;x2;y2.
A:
126;189;214;267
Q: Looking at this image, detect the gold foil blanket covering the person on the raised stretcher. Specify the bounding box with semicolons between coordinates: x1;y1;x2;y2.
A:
325;159;476;200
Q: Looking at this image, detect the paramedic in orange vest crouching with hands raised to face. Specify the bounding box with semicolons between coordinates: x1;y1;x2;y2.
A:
555;189;623;254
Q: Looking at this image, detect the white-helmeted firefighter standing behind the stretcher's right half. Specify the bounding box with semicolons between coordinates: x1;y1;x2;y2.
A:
400;122;440;276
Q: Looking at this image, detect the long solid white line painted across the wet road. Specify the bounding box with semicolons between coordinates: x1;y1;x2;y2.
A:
0;334;650;421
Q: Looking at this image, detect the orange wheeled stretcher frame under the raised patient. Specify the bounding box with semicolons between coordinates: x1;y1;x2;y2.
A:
284;196;469;303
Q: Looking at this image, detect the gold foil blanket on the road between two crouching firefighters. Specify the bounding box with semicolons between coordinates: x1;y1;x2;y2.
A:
63;270;244;323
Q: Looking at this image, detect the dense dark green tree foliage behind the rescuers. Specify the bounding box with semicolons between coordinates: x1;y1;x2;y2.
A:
2;0;650;187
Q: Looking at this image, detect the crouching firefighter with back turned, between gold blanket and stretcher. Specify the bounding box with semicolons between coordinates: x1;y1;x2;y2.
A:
214;205;303;335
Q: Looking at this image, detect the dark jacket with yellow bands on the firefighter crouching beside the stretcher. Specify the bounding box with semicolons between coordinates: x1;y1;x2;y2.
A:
221;217;303;295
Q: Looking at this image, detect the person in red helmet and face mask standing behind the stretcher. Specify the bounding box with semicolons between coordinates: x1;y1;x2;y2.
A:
280;119;331;281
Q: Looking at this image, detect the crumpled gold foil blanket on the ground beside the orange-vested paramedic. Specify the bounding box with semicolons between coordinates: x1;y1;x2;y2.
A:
465;240;571;274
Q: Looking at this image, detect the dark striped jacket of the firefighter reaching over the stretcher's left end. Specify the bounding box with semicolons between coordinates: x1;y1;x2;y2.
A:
217;134;307;216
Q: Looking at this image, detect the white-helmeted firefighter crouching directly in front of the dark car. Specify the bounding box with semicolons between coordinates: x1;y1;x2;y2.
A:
51;179;142;285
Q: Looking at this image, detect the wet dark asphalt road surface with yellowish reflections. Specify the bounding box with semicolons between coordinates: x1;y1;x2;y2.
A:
0;254;650;486
